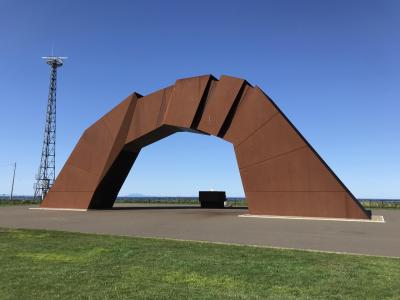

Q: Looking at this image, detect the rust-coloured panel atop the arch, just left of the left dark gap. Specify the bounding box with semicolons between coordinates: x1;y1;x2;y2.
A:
163;75;213;128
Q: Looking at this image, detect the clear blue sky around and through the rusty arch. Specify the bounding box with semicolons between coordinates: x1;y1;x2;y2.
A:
0;0;400;198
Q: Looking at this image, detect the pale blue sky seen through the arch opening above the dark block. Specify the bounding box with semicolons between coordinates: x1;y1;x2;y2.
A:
118;132;244;202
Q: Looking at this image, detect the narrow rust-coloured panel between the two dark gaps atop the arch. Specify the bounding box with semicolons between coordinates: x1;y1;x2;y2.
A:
197;76;246;136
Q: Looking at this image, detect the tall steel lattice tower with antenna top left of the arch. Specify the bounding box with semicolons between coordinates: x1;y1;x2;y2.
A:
33;56;67;200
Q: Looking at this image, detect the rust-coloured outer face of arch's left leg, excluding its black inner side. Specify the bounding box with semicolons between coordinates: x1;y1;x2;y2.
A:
41;94;140;208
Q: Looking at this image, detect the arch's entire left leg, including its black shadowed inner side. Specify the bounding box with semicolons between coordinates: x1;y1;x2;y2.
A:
40;94;140;209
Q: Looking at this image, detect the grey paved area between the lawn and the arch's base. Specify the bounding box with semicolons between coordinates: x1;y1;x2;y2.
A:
0;204;400;257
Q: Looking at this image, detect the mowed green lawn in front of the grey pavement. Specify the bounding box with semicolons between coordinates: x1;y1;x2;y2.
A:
0;229;400;299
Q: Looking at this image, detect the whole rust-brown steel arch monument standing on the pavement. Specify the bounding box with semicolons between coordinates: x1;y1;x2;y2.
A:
41;75;370;219
